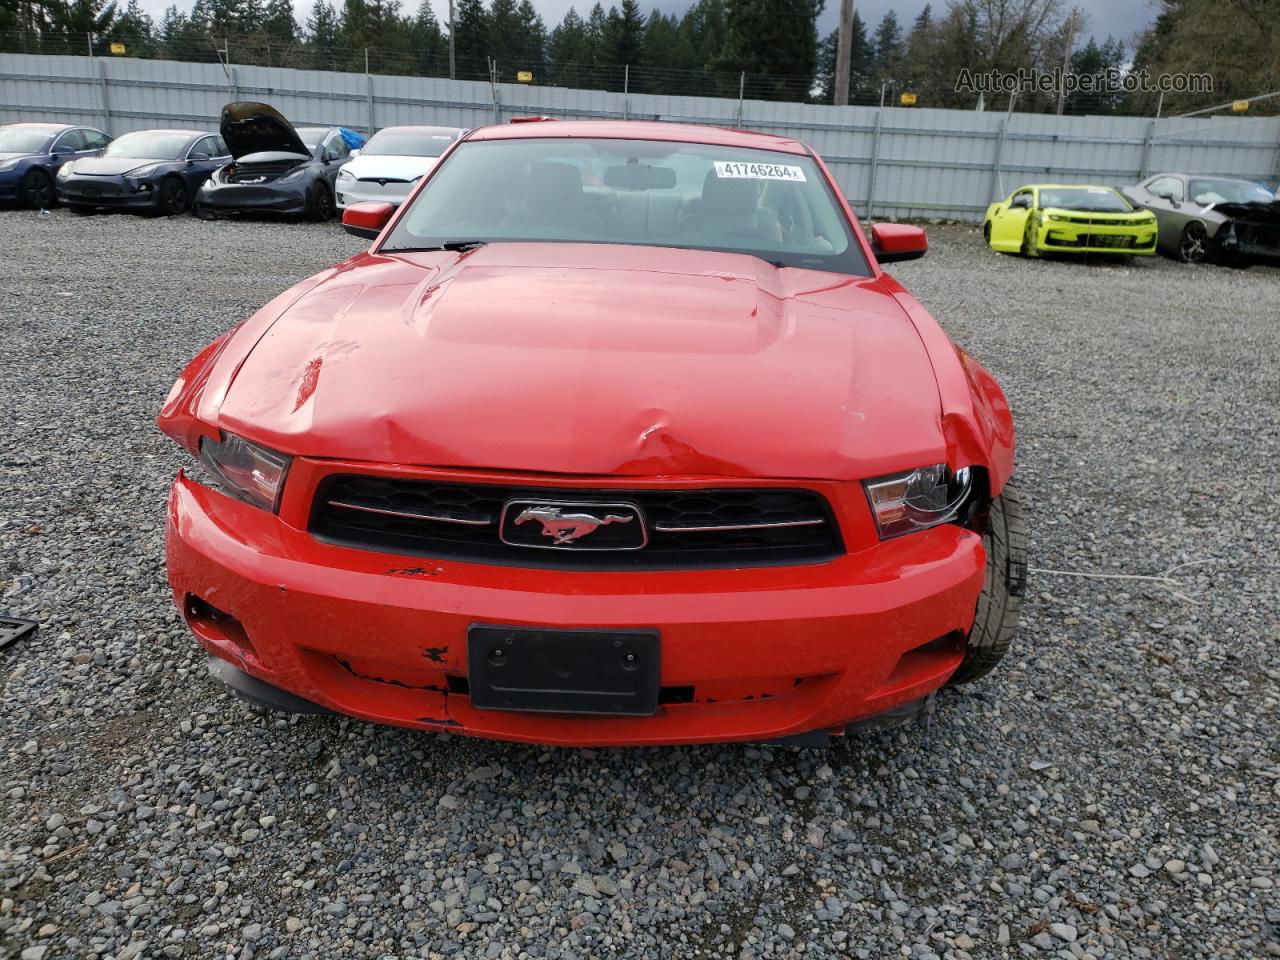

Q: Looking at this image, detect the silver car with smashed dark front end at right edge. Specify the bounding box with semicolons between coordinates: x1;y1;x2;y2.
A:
1120;173;1280;265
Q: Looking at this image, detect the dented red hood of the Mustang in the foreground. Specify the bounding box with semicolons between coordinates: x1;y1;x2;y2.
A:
214;243;946;479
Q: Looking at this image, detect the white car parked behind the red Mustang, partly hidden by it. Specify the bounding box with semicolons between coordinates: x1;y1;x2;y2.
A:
335;127;466;209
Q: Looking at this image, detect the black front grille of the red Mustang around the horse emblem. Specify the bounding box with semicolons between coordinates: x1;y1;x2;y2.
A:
310;475;844;570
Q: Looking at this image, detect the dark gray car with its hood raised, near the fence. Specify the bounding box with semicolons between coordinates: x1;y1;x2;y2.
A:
196;102;364;220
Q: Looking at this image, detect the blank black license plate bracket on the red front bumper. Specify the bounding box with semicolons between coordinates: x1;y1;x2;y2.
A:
467;623;660;717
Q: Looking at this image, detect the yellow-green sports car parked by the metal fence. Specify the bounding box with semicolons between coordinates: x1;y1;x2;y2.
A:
982;183;1158;256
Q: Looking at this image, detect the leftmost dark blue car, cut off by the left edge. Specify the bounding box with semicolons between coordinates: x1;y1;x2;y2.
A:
0;123;111;210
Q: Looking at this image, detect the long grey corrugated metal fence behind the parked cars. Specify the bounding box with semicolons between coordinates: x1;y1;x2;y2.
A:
0;54;1280;220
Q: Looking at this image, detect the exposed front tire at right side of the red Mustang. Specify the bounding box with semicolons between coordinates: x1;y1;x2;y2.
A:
951;479;1027;684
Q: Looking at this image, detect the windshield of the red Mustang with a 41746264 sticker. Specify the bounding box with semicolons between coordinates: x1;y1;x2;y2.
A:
381;138;869;275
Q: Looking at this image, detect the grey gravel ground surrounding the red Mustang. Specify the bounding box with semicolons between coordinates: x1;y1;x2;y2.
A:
0;211;1280;960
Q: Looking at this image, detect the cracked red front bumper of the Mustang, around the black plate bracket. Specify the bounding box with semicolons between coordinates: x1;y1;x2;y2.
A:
166;475;984;746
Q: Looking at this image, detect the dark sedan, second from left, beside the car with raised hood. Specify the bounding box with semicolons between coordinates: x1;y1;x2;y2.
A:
58;129;232;216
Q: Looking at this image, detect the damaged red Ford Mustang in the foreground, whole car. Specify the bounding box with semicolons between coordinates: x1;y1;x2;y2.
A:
159;122;1025;745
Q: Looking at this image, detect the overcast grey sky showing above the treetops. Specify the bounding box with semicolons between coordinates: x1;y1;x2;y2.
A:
140;0;1156;52
